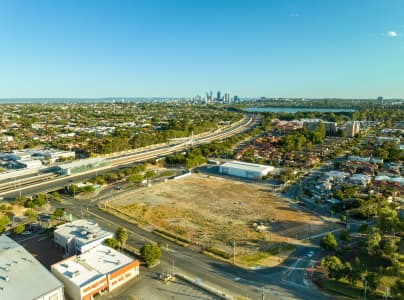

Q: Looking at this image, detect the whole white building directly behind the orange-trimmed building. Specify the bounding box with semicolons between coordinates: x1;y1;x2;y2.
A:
53;219;114;256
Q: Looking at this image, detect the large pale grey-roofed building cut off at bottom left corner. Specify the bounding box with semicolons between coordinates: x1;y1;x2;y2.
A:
0;235;64;300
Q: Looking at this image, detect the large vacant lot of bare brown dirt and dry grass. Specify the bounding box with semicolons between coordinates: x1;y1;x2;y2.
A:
109;174;325;266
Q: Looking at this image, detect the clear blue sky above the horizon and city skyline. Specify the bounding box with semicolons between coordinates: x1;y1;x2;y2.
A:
0;0;404;98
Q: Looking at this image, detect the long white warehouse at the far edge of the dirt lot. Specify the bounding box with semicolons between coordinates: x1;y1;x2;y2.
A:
219;161;275;179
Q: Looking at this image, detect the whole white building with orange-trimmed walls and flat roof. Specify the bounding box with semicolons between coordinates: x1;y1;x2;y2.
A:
51;245;140;300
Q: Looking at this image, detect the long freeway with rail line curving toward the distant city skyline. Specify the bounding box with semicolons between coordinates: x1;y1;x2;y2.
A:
0;116;260;198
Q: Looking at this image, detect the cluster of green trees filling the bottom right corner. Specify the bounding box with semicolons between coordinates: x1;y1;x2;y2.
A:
320;207;404;299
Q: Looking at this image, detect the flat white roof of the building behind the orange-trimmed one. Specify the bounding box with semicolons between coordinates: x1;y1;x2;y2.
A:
55;219;112;244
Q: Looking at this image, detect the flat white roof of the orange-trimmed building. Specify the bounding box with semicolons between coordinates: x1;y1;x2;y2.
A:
52;245;134;287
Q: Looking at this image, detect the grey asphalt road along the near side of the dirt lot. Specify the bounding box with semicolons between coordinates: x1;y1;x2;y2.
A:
56;195;327;299
